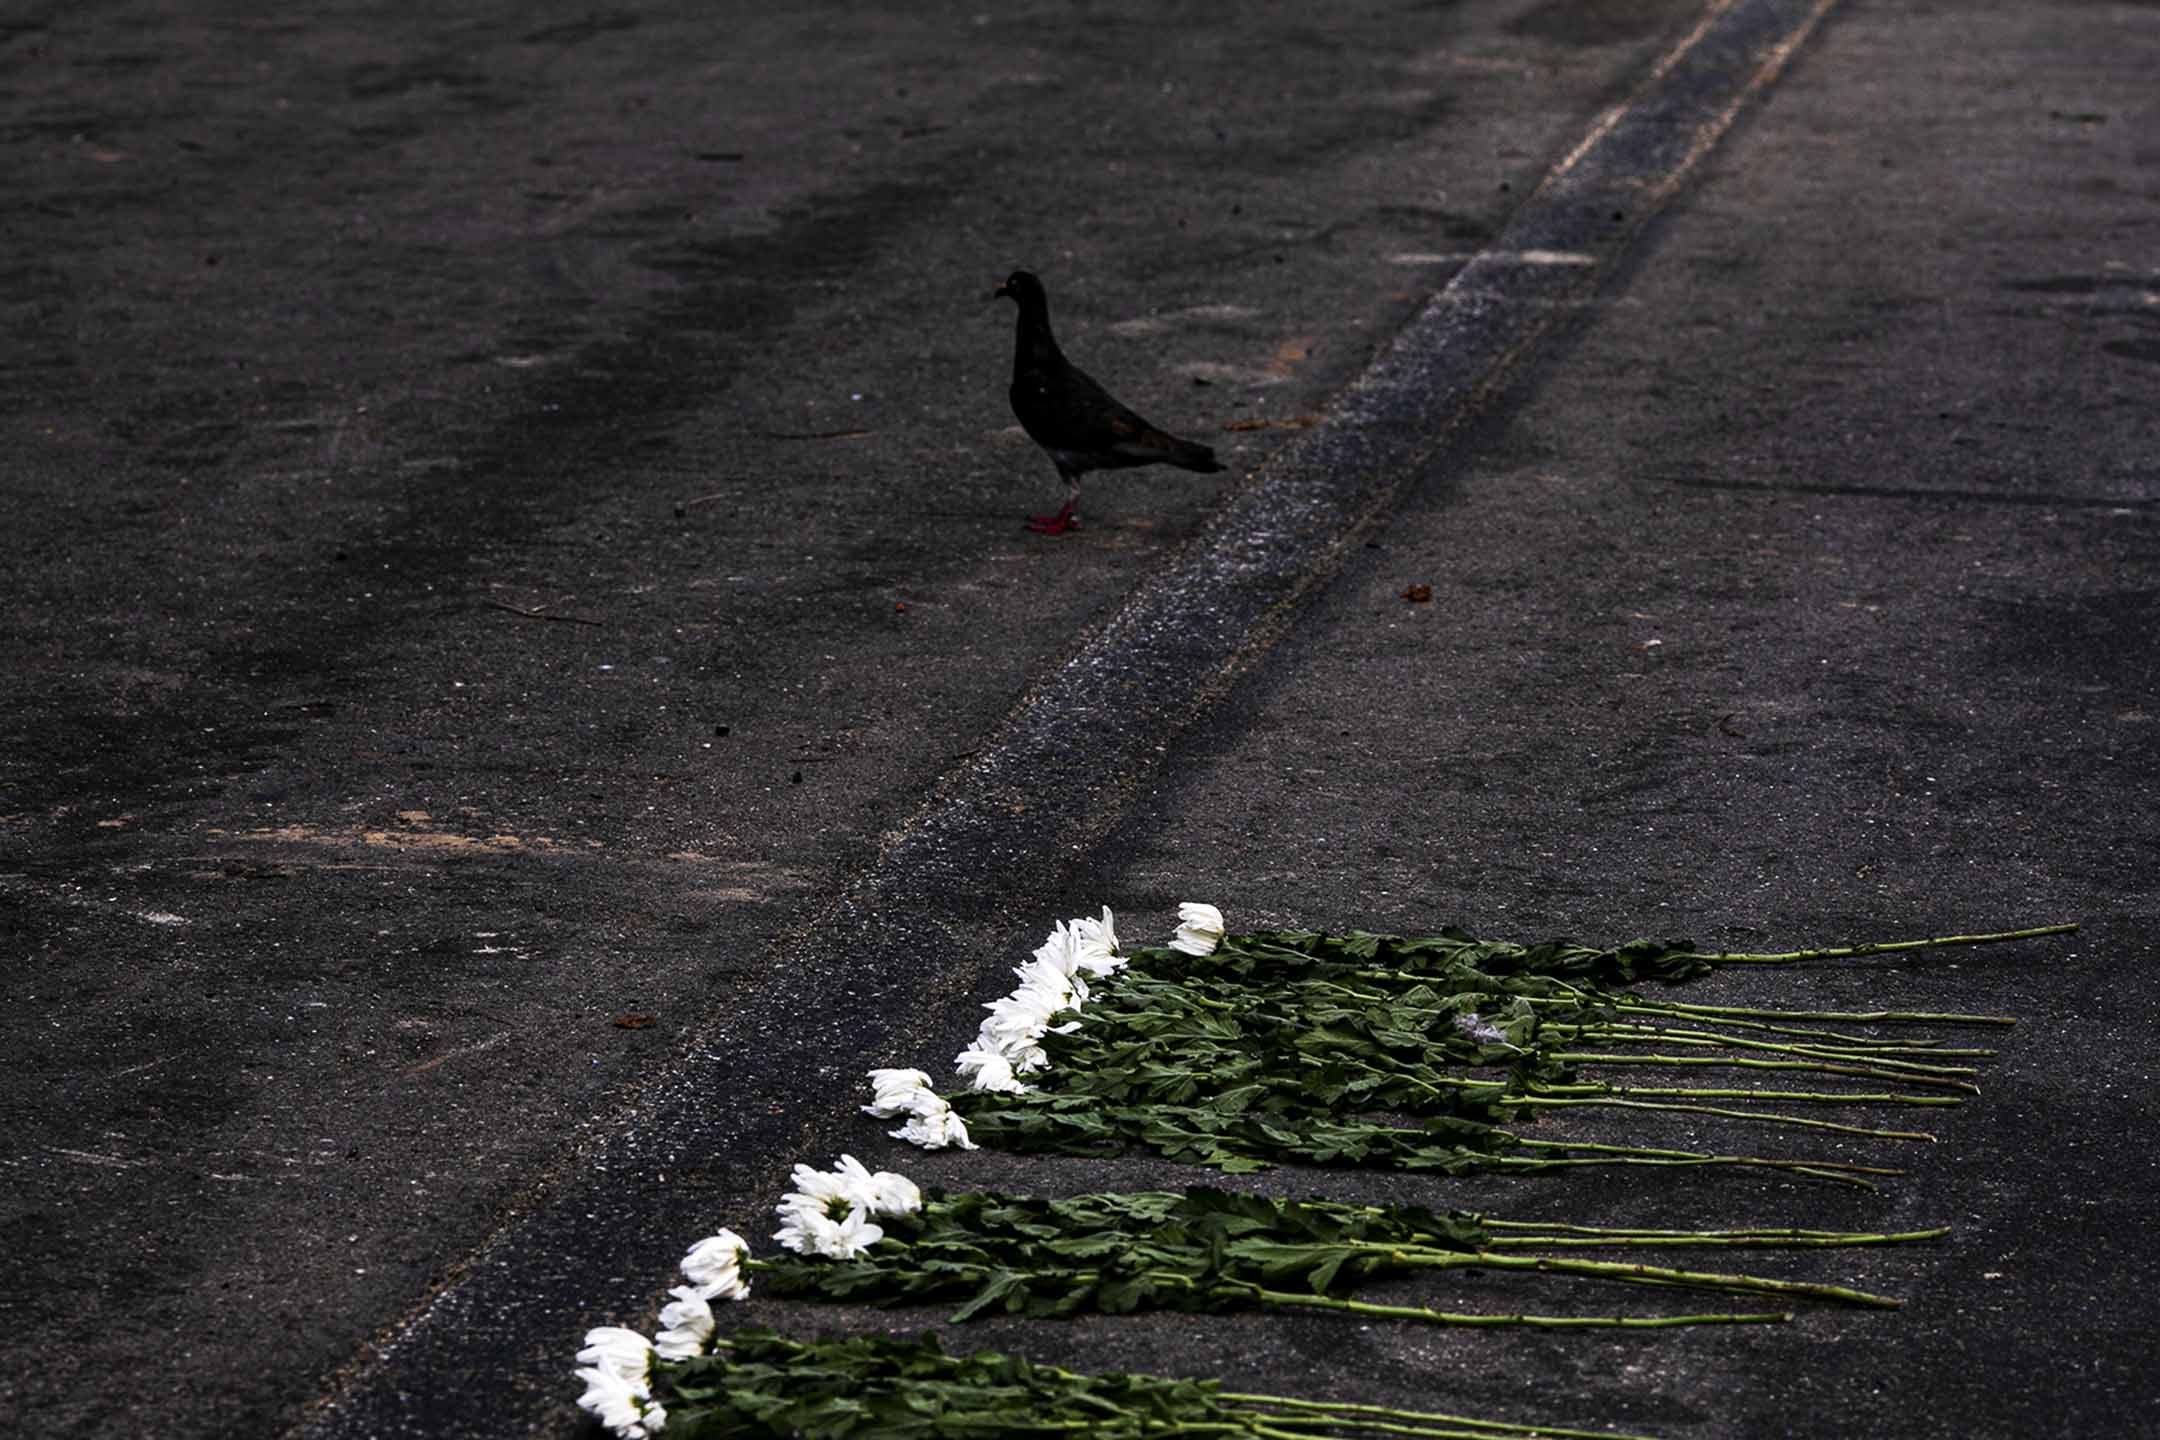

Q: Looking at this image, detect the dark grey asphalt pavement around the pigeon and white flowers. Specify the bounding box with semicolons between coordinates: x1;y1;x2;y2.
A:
0;0;2160;1436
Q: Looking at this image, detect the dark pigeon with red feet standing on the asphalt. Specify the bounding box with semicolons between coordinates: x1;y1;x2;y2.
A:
989;270;1225;535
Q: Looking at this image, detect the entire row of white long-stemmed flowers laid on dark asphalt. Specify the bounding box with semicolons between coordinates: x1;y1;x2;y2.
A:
577;905;2076;1440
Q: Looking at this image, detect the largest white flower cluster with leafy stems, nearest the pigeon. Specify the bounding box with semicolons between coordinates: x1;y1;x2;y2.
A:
866;905;2076;1187
